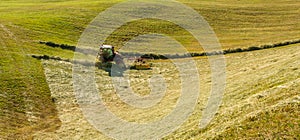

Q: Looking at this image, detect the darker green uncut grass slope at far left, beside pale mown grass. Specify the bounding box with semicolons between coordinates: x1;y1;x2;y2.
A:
0;24;60;139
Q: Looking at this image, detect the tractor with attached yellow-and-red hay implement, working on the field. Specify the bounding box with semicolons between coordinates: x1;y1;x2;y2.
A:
96;45;152;71
